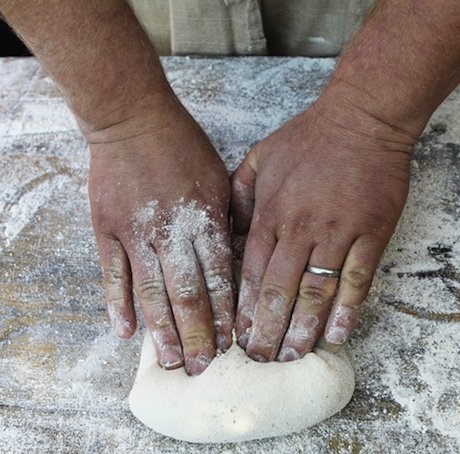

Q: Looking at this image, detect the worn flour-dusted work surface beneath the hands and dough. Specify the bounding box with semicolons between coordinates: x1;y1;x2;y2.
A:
0;58;460;454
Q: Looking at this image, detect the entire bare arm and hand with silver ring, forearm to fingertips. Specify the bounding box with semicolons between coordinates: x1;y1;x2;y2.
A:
233;0;460;361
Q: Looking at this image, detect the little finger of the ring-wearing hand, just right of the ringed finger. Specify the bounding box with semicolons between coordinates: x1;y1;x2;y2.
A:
325;235;385;344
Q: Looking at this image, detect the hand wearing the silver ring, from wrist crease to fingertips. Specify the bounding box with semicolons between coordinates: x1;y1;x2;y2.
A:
232;89;415;361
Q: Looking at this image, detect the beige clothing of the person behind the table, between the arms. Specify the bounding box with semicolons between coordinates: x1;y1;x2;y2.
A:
128;0;374;57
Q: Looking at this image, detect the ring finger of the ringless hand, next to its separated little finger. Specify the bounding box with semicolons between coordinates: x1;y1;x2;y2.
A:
131;243;184;369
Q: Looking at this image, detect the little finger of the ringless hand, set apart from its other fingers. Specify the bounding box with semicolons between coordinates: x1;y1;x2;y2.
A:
97;236;136;339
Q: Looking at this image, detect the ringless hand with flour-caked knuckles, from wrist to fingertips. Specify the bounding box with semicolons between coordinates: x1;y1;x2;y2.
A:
89;97;234;375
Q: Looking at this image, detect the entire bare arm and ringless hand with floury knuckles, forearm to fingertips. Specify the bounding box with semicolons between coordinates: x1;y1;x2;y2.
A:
0;0;234;375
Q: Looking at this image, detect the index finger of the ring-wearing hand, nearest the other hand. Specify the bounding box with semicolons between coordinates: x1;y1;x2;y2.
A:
235;216;276;348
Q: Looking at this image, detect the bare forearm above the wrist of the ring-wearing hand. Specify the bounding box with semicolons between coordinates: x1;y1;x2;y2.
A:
326;0;460;137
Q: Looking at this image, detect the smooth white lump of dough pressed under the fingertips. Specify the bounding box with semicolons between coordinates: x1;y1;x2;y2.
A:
129;335;354;443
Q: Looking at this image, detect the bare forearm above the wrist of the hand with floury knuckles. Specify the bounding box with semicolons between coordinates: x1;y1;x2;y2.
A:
0;0;170;135
